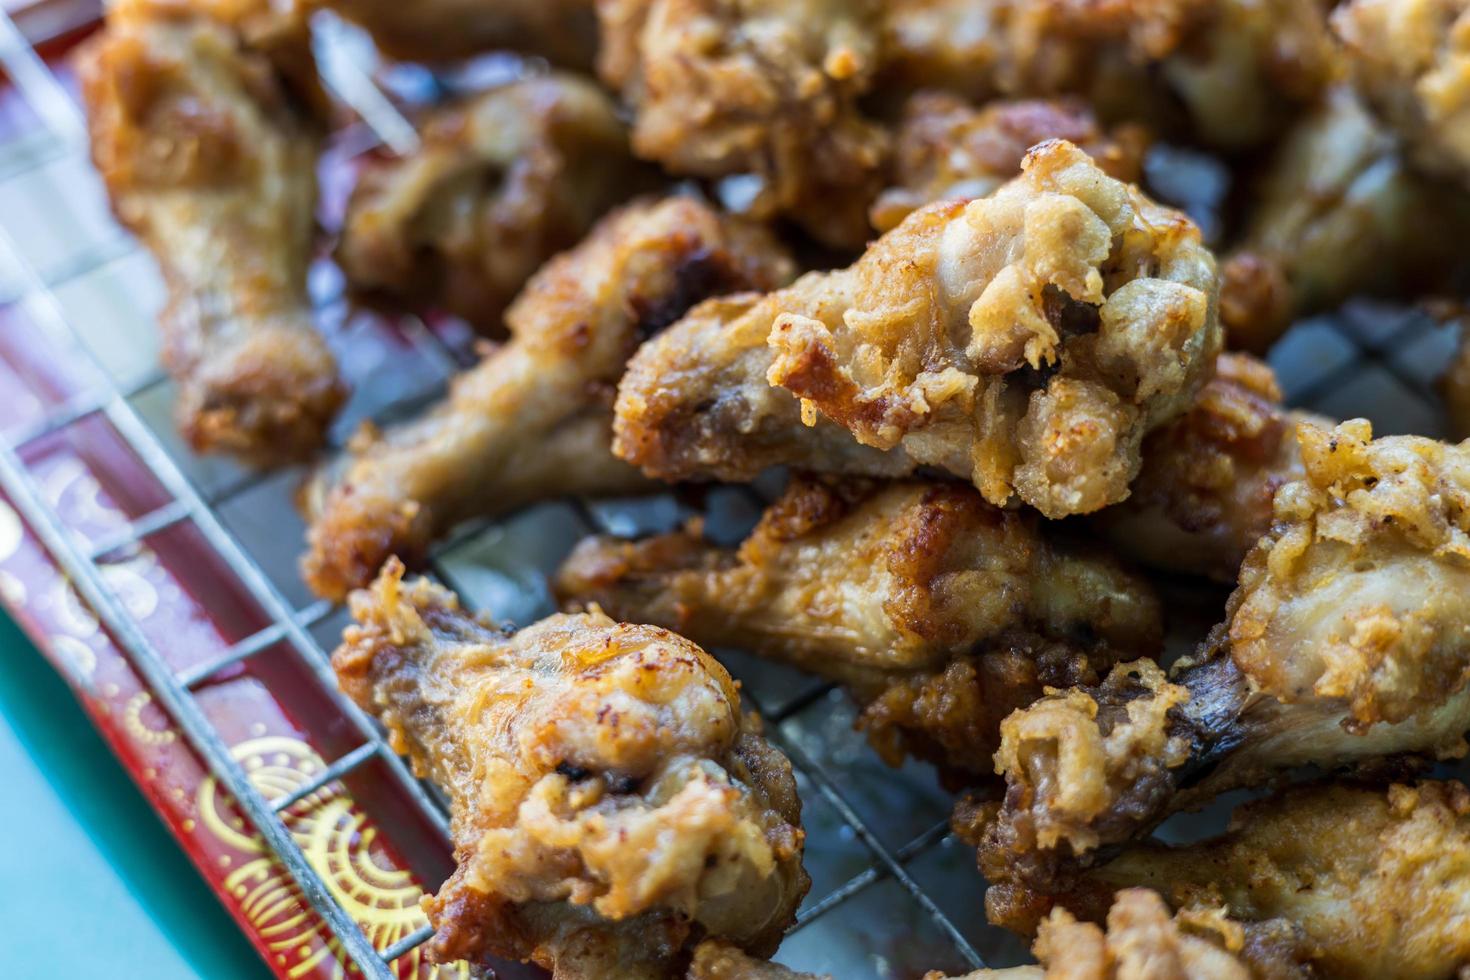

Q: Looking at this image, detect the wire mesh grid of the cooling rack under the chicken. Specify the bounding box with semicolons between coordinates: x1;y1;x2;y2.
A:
0;3;1454;980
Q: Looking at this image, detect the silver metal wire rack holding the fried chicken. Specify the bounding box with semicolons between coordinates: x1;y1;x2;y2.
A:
0;3;1452;980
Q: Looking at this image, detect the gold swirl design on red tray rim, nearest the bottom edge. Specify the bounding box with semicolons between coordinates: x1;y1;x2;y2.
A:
197;736;469;980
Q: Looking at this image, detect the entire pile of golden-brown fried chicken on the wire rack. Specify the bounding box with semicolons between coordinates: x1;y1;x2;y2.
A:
79;0;1470;980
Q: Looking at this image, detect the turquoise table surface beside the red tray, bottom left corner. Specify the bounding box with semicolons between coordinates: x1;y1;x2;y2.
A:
0;611;270;980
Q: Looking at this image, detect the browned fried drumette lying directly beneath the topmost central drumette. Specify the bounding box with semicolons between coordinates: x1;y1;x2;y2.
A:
556;479;1163;785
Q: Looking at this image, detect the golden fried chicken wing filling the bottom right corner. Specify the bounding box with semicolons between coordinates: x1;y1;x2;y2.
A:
1034;782;1470;980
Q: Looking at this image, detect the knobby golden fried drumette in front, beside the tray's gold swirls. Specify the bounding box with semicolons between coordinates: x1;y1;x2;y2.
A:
332;563;810;980
